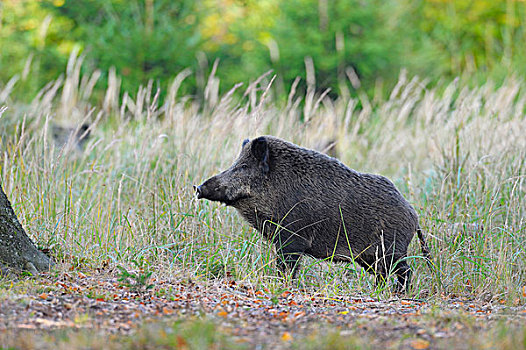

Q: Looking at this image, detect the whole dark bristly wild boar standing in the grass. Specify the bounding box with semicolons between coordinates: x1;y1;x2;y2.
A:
195;136;429;288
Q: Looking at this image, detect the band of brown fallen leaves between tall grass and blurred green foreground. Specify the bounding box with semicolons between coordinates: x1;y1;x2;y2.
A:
0;271;526;349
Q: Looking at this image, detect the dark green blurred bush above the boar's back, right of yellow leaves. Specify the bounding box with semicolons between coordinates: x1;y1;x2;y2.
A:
272;0;403;93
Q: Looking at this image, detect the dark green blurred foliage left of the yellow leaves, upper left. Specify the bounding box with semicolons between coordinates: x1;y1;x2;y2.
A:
43;0;202;92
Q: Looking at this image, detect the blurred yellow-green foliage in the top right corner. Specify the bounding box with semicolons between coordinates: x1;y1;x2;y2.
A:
407;0;526;83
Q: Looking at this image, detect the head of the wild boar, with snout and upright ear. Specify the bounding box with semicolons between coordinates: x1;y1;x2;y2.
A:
194;137;269;207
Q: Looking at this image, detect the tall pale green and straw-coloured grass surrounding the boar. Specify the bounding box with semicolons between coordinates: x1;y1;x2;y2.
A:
0;52;526;348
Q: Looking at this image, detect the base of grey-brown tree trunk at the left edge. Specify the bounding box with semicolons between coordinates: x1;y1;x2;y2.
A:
0;185;54;274
